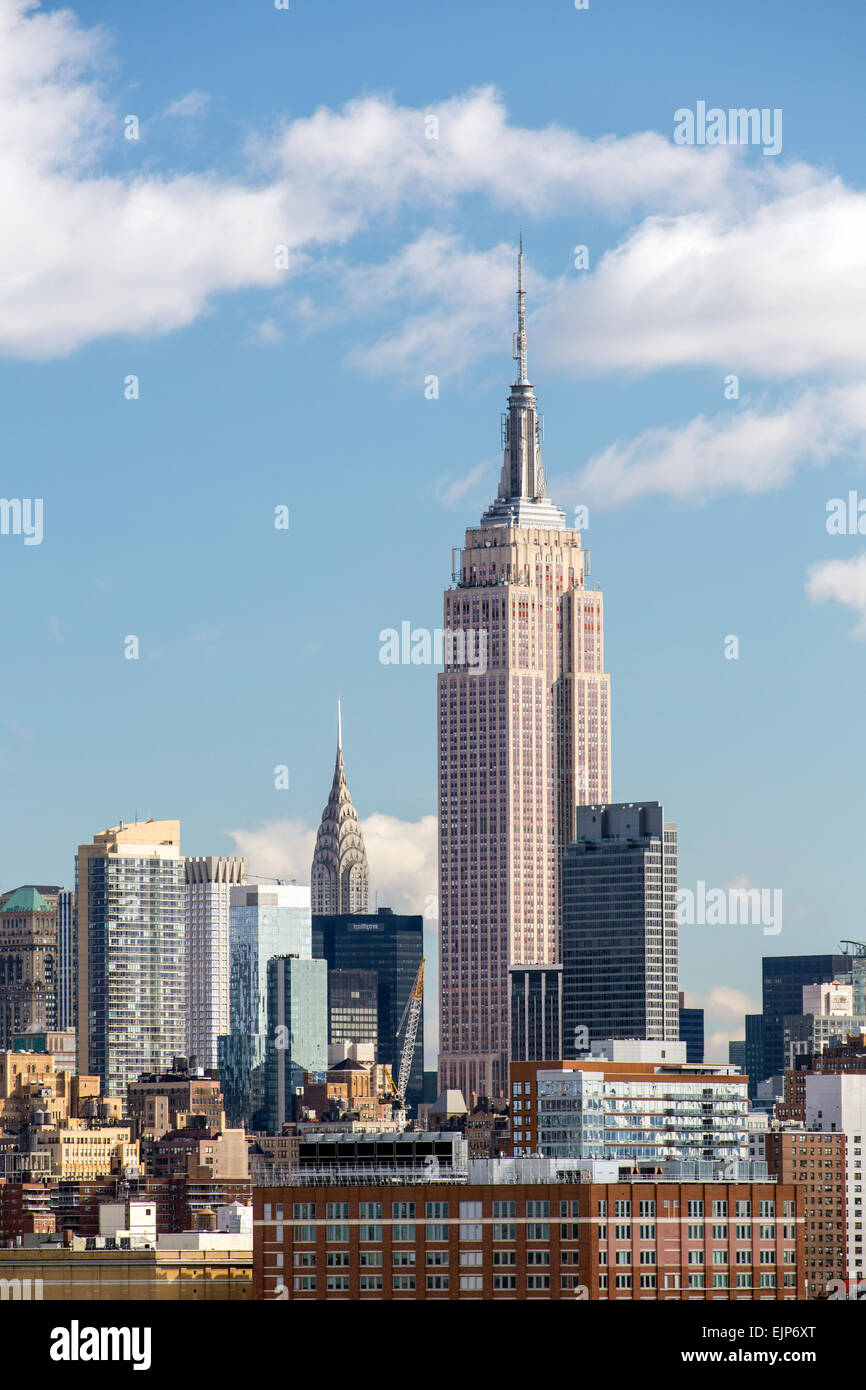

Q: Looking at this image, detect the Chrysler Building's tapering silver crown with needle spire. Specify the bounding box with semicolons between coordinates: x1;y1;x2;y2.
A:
310;701;370;913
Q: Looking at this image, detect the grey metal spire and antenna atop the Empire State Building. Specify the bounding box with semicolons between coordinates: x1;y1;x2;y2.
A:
481;232;566;531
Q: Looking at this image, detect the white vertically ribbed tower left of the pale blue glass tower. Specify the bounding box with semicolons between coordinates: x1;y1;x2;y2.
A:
186;855;246;1068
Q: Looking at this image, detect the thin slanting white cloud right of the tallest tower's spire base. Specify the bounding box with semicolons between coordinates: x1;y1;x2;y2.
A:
553;385;866;506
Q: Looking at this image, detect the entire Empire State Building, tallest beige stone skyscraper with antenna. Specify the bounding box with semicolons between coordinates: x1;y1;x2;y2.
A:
438;247;610;1095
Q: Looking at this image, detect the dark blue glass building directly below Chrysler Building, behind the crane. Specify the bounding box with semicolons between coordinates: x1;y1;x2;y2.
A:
313;908;424;1105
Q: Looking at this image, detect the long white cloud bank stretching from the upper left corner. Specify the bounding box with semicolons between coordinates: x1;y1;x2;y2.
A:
0;0;812;368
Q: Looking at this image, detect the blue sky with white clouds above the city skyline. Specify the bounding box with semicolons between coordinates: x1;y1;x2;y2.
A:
0;0;866;1055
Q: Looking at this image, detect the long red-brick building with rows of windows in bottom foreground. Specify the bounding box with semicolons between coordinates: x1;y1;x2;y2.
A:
253;1175;805;1301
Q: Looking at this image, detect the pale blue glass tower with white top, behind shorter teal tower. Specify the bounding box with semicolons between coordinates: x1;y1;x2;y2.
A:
217;884;311;1129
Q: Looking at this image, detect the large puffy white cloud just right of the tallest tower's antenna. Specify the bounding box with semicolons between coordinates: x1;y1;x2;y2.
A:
539;178;866;378
